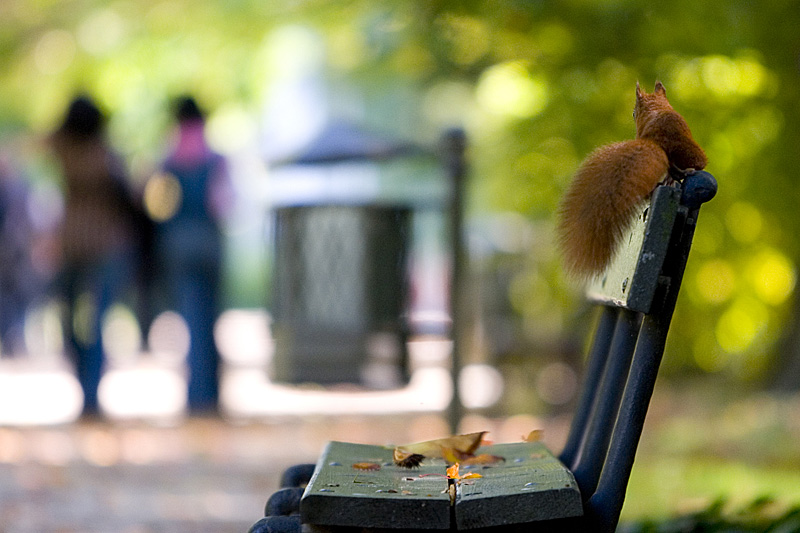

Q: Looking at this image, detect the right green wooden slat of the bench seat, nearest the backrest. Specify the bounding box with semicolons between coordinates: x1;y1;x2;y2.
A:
455;442;583;530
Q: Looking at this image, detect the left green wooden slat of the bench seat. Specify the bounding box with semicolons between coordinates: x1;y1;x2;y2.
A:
300;442;450;529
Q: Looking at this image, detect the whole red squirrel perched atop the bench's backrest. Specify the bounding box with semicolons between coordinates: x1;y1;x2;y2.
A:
557;81;707;279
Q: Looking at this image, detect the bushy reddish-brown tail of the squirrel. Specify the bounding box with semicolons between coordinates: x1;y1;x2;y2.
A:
558;139;669;279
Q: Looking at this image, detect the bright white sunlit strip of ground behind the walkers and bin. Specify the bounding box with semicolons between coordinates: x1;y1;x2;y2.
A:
0;309;516;425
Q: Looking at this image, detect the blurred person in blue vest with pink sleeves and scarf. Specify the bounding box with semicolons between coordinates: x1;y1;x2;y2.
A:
155;96;230;413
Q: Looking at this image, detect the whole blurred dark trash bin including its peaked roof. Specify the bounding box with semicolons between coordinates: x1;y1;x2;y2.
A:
271;122;439;388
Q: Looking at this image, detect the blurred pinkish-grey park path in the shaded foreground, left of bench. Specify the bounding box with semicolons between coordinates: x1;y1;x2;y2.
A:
0;414;552;533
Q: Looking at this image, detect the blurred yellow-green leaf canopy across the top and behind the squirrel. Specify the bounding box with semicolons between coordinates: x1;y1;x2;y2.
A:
0;0;800;379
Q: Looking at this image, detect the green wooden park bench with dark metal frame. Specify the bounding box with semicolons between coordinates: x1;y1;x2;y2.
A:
251;171;716;533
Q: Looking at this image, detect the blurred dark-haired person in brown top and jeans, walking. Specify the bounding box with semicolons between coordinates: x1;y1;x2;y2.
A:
49;95;137;415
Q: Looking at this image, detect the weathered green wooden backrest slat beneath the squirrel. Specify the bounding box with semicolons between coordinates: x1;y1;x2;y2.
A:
586;186;681;313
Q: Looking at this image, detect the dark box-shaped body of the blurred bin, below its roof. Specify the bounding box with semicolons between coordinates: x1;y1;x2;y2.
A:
272;205;411;388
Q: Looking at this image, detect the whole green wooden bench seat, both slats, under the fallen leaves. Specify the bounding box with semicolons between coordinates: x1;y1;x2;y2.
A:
300;442;582;530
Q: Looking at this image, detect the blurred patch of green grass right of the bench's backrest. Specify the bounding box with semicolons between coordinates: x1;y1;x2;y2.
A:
621;376;800;531
